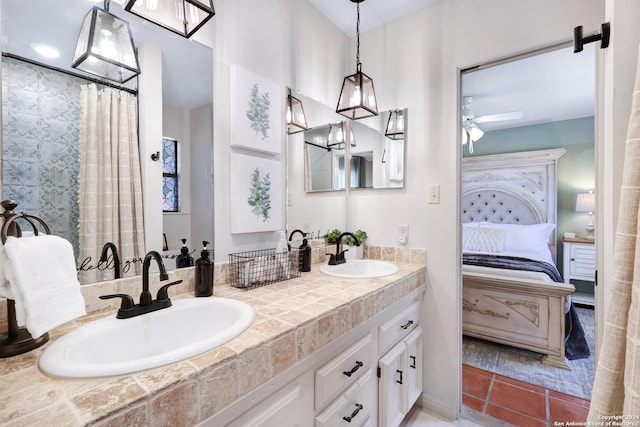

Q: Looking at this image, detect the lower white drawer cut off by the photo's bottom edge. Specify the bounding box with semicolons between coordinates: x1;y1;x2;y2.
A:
315;368;377;427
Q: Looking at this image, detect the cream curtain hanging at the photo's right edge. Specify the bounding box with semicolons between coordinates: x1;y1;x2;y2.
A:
589;46;640;418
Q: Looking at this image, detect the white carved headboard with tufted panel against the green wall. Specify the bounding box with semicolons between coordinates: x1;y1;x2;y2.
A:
462;148;567;258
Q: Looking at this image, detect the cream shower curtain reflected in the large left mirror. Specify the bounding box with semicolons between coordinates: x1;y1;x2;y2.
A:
78;84;145;283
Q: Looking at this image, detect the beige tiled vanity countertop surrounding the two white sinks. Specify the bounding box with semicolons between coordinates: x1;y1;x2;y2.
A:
0;263;426;427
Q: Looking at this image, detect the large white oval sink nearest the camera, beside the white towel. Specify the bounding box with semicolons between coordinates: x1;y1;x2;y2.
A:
39;297;254;378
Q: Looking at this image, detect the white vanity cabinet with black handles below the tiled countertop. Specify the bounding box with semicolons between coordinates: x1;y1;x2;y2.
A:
201;290;424;427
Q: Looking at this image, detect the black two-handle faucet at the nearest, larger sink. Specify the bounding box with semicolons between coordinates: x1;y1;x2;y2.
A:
100;251;182;319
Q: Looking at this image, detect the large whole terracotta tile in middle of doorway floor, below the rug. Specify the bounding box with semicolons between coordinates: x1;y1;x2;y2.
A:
489;381;547;420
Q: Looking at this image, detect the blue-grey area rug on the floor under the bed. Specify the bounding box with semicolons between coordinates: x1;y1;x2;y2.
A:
462;307;595;400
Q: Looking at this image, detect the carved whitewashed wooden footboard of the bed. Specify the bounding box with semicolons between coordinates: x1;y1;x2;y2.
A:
462;272;575;369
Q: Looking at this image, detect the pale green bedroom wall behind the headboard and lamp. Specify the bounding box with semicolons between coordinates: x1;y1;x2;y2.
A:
463;117;596;273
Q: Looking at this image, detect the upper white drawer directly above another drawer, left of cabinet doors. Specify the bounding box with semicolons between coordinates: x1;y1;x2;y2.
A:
315;334;375;411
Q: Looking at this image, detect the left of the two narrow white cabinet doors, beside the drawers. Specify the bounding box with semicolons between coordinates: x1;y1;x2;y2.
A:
378;342;408;427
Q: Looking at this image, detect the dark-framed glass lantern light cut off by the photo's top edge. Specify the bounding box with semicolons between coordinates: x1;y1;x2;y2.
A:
124;0;216;38
